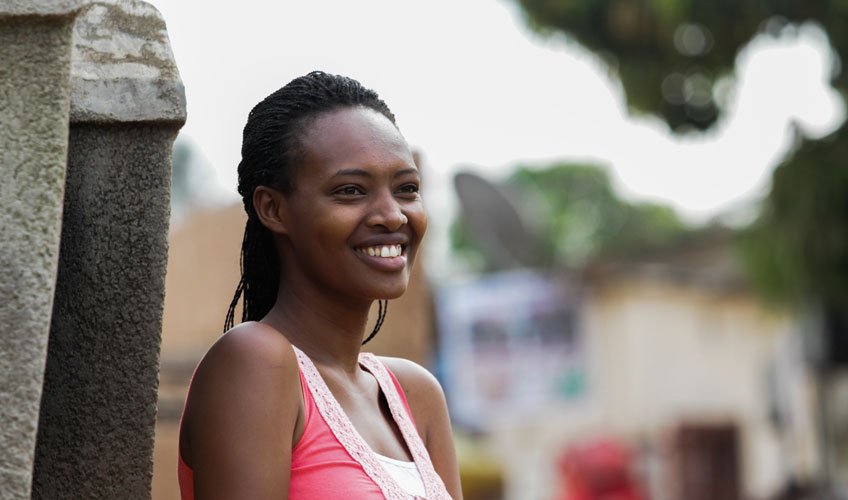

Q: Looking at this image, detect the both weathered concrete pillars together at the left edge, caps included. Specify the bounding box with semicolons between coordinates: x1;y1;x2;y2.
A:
0;0;185;499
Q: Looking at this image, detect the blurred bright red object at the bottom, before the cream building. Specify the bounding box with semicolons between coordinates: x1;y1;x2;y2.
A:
554;439;646;500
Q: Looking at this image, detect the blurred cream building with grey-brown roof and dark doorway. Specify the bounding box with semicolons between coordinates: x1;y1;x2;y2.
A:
585;237;817;499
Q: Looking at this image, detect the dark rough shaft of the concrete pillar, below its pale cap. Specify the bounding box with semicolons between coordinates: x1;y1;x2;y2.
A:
33;124;176;499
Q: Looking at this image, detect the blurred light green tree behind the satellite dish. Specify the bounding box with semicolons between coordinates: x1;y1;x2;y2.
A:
451;164;694;270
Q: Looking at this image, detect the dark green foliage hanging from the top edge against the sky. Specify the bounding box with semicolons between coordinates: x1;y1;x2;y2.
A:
515;0;848;130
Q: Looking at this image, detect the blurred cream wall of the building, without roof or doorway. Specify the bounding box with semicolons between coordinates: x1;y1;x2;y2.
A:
584;278;793;497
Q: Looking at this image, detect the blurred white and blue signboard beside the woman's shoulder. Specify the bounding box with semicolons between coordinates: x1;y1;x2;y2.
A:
437;271;588;430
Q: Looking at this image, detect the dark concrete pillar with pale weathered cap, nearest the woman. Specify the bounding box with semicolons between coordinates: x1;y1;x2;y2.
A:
32;0;185;499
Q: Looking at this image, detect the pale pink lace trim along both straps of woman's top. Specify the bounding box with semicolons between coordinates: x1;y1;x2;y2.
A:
292;346;450;500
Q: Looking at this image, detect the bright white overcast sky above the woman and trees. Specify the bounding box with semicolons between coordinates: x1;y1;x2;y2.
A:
151;0;844;272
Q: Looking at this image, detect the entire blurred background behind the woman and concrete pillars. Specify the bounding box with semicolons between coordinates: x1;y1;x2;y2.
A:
152;0;848;500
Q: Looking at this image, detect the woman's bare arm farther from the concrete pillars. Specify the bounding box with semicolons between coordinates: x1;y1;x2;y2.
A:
381;358;462;500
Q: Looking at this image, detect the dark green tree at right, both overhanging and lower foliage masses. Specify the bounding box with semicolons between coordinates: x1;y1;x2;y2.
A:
514;0;848;314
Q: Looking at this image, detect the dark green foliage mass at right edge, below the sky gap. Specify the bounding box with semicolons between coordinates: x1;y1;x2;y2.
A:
742;125;848;308
